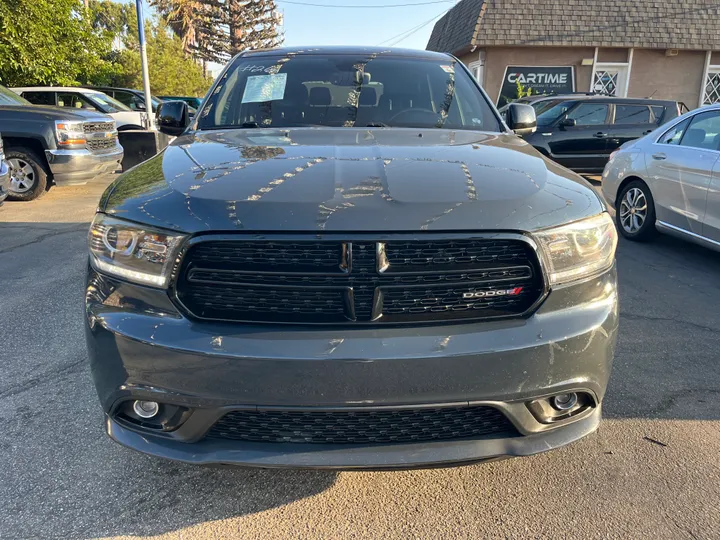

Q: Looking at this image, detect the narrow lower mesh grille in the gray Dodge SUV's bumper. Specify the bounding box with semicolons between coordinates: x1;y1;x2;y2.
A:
207;406;519;444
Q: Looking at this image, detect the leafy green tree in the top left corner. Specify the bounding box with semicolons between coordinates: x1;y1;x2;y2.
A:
0;0;112;86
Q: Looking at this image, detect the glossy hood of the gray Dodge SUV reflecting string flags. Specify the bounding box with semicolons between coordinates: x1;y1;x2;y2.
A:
101;128;604;233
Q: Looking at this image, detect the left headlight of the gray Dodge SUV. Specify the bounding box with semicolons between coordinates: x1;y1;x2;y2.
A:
88;214;185;288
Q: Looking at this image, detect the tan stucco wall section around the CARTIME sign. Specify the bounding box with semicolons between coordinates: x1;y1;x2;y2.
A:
460;47;595;101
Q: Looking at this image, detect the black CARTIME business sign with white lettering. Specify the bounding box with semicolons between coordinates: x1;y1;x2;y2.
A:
498;66;575;106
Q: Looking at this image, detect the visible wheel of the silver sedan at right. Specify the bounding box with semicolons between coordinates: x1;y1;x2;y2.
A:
615;180;657;242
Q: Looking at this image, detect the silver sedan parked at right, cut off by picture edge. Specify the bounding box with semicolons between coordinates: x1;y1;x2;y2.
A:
602;104;720;251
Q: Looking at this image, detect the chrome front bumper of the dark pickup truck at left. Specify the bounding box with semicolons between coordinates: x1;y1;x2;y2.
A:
45;144;123;186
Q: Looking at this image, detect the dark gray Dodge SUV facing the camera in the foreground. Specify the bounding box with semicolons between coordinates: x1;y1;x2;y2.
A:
85;48;618;469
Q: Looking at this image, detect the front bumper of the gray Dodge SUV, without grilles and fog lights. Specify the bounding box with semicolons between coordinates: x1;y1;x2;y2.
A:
86;268;618;469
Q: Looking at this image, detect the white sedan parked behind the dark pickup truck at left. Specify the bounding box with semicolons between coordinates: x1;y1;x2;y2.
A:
10;86;147;131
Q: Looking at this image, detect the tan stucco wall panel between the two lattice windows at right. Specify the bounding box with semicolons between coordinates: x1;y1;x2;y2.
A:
628;49;705;109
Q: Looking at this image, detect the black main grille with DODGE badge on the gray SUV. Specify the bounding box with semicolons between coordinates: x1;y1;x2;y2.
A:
176;238;543;324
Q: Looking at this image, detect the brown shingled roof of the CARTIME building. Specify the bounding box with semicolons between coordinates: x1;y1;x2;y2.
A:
427;0;720;53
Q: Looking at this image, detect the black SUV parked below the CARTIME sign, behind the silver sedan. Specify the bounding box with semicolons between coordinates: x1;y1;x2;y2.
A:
525;95;685;174
